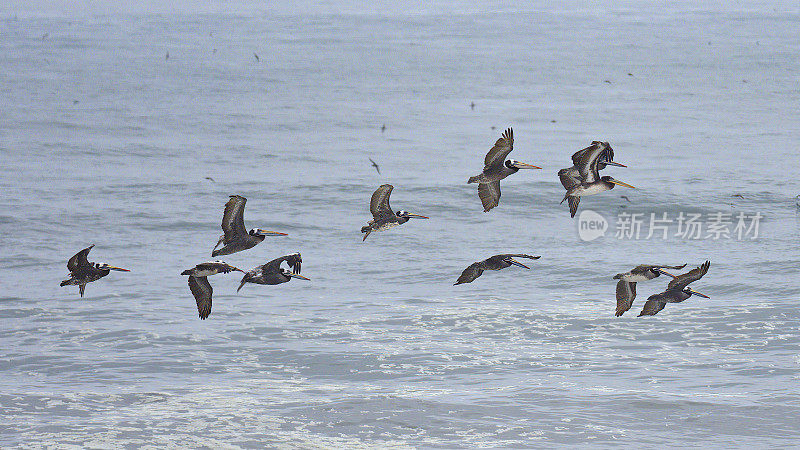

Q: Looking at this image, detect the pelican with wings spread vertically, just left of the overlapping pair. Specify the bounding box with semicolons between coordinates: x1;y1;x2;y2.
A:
467;128;541;212
